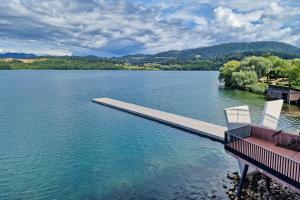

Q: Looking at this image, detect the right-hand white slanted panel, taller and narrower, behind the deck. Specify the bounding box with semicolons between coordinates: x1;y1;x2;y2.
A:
259;100;283;129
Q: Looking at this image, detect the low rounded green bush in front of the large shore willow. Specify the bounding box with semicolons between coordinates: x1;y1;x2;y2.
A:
230;71;257;88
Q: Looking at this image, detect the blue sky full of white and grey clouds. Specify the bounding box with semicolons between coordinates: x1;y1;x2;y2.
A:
0;0;300;57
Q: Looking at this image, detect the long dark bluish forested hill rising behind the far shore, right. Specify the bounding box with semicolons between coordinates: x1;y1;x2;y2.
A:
120;42;300;70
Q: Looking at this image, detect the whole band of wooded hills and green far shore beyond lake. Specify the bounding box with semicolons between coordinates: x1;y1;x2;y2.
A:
0;41;300;71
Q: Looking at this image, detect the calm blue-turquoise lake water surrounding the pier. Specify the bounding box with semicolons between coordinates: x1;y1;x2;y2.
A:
0;71;300;199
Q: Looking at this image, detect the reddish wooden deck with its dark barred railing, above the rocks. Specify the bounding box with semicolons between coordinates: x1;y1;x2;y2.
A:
225;130;300;193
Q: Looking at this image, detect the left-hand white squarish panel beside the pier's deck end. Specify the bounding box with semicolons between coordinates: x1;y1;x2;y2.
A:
224;106;251;130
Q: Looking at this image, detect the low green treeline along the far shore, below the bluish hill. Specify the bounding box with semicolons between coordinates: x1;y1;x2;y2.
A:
0;52;296;71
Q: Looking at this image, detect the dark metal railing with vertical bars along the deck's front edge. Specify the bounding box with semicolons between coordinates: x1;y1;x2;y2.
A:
225;132;300;189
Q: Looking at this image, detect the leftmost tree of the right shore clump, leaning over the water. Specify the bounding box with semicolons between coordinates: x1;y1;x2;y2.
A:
219;60;240;87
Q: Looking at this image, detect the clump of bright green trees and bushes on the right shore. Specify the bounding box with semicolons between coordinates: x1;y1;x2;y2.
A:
219;55;300;94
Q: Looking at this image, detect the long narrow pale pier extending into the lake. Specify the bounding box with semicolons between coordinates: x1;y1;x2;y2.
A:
92;98;227;143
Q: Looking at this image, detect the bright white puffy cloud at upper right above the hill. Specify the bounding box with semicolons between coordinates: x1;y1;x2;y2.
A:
214;2;300;46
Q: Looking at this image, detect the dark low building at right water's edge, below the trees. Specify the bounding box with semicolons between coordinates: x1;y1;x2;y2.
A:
267;85;300;104
